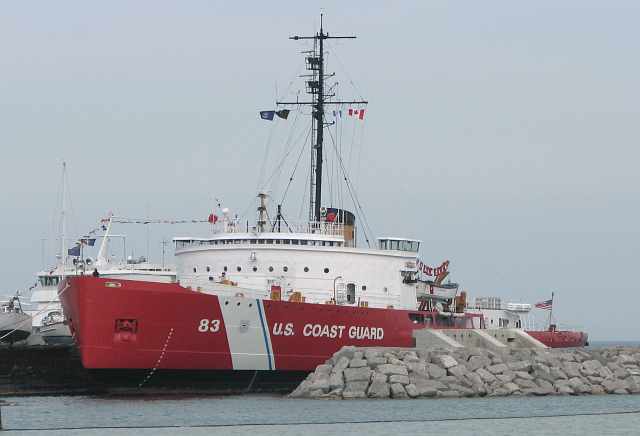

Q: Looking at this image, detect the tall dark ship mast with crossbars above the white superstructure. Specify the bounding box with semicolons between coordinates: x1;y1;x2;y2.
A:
276;14;368;222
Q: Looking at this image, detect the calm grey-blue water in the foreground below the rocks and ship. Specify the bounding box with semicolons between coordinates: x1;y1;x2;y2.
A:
2;395;640;436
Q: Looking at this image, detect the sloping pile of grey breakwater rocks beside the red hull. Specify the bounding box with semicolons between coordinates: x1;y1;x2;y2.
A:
290;347;640;399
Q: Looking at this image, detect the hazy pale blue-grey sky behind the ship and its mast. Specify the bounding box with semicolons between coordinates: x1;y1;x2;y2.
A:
0;0;640;340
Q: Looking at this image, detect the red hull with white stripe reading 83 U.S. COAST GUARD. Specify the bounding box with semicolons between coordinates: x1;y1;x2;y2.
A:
59;276;584;371
